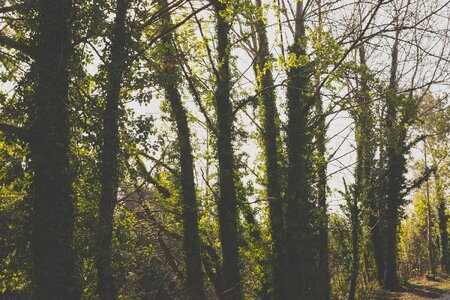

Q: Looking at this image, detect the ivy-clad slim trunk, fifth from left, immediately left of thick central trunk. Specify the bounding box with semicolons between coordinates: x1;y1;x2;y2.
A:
255;0;285;299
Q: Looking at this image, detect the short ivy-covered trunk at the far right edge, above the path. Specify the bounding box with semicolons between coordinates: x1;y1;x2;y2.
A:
435;172;450;273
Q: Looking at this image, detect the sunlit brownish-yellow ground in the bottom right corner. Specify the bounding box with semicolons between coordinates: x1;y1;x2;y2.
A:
370;277;450;300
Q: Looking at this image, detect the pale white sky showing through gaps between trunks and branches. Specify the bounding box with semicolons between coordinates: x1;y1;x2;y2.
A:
107;0;450;211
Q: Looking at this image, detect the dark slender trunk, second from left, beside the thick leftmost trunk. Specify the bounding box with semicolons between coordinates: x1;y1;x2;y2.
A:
96;0;129;300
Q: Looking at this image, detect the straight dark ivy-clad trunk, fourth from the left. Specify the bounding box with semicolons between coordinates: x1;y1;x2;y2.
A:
214;1;242;300
